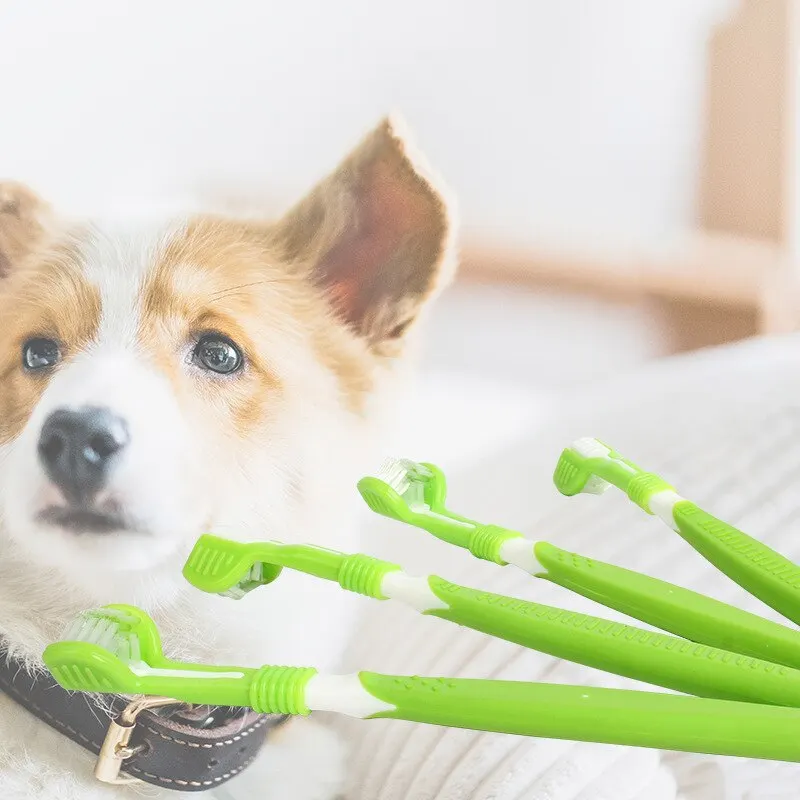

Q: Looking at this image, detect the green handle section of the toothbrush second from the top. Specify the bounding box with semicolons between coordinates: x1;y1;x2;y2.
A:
534;542;800;669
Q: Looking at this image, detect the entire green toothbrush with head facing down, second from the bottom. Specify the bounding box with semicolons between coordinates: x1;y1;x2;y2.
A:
183;535;800;707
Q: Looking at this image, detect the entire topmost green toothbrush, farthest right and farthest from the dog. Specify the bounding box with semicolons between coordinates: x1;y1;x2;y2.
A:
554;439;800;623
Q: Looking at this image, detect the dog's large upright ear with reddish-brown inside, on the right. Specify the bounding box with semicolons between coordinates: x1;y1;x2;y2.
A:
276;119;455;346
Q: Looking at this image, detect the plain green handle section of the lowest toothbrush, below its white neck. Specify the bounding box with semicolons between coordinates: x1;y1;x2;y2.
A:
359;672;800;762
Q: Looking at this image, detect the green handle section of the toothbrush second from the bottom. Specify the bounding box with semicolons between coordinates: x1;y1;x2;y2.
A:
428;575;800;707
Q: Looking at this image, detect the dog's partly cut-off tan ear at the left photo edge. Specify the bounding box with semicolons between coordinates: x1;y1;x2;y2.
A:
0;181;50;279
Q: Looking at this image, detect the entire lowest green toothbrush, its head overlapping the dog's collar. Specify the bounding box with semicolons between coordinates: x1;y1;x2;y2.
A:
44;605;800;762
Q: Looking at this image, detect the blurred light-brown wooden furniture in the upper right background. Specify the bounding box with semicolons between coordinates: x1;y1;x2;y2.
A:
462;0;800;343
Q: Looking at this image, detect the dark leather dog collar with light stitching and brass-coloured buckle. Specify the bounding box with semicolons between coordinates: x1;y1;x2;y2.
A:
0;643;288;792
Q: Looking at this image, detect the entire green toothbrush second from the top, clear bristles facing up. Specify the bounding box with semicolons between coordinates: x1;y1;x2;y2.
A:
358;459;800;669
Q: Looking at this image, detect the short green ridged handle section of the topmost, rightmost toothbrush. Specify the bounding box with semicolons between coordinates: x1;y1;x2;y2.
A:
672;500;800;624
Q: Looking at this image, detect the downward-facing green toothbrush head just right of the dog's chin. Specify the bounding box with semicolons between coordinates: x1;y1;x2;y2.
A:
183;534;281;600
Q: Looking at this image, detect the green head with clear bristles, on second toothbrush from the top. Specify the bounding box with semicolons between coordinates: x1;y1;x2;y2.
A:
358;458;447;523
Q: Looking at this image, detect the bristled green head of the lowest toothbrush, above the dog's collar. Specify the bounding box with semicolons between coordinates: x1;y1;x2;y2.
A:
43;605;164;694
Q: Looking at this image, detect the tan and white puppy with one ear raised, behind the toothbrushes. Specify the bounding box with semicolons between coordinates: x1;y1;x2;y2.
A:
0;118;455;800
